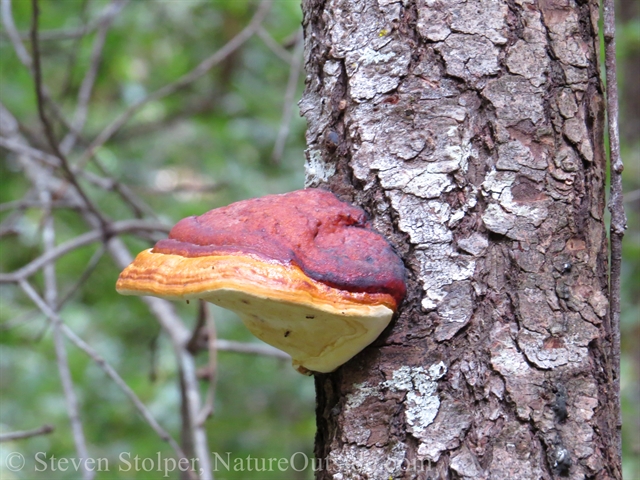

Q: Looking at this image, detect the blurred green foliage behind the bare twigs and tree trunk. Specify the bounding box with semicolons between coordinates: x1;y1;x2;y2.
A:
0;0;640;480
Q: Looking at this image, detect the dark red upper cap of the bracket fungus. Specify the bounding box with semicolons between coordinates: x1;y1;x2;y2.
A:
152;188;406;307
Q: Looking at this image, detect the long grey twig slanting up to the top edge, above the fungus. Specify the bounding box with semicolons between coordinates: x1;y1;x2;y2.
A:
77;0;272;168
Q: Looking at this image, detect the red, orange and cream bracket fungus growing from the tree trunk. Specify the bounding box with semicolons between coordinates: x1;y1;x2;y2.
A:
116;189;406;373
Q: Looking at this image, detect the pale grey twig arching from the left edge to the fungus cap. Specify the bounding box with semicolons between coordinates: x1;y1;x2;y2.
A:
0;220;169;284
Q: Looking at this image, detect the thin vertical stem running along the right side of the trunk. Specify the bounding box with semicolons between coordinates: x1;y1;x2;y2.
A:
603;0;627;464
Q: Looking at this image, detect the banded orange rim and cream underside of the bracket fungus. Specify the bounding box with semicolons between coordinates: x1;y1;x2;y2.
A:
116;249;393;373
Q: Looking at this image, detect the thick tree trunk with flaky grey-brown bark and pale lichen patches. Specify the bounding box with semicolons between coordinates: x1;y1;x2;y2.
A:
300;0;621;480
